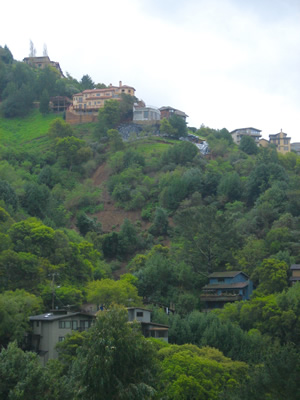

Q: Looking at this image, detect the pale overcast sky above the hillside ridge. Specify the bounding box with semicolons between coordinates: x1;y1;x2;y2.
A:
0;0;300;142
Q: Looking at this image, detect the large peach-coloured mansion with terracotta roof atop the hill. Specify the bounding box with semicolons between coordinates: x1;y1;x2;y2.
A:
73;81;135;112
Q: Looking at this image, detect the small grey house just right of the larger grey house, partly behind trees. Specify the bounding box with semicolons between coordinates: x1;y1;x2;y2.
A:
127;307;169;342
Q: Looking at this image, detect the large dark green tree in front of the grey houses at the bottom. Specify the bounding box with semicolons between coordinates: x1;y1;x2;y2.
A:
72;306;156;400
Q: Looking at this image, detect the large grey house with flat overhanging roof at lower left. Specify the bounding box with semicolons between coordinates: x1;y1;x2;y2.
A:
29;311;95;365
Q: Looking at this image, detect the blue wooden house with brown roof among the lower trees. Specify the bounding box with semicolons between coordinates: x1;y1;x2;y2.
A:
200;271;253;310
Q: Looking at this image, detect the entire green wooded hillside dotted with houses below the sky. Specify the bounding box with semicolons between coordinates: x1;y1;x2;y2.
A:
0;46;300;400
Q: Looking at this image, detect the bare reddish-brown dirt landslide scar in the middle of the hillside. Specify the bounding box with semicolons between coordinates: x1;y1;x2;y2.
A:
92;163;150;233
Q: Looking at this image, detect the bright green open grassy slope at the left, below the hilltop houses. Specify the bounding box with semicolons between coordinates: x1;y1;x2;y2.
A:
0;110;60;150
